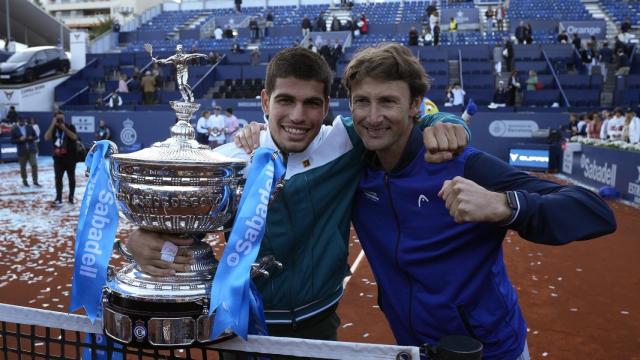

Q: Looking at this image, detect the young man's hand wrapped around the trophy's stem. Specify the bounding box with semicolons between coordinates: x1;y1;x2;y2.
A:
126;229;193;276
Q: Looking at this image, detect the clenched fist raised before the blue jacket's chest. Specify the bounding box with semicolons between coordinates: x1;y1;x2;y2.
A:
438;176;511;223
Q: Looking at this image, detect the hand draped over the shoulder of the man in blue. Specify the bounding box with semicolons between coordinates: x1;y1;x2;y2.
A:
422;123;469;163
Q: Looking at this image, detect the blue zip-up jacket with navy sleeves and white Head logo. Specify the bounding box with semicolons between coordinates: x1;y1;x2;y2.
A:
353;125;616;359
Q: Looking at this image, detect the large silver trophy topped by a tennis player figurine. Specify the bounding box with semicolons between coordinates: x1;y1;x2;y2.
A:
103;44;280;347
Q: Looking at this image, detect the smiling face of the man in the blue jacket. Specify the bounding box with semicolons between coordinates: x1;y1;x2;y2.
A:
350;78;420;170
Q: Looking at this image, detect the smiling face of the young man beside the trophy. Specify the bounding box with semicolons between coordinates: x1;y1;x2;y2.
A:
260;77;329;153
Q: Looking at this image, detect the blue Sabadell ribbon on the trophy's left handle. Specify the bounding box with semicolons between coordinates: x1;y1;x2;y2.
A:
69;140;118;323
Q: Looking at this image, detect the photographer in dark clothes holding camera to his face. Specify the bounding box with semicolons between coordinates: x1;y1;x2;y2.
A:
44;111;78;206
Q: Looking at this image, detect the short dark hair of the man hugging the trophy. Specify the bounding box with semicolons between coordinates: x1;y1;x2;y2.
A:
265;46;333;97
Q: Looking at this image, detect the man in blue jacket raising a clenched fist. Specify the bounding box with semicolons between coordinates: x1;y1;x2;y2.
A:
343;44;616;360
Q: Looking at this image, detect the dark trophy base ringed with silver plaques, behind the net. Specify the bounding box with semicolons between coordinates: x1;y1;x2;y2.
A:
102;291;236;348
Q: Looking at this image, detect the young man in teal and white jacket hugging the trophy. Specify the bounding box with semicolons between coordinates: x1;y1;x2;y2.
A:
127;47;467;340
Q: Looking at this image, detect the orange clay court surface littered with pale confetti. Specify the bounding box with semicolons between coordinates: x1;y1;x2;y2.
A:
0;157;640;359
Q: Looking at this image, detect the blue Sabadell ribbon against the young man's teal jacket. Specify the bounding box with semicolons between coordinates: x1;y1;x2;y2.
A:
209;148;285;340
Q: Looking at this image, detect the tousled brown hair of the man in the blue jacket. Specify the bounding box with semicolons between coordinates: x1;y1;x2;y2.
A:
342;43;431;98
